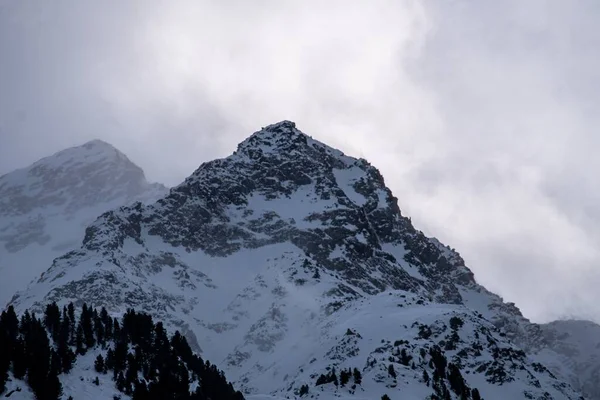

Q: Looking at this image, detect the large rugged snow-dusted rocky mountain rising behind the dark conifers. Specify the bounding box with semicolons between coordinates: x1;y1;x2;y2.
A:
0;121;597;399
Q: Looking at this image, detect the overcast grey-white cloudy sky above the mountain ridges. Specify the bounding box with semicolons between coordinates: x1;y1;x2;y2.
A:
0;0;600;321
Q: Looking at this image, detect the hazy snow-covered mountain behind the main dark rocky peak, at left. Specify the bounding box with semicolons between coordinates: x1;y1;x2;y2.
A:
0;140;167;305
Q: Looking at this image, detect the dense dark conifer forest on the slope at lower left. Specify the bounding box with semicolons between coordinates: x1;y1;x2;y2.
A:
0;303;244;400
